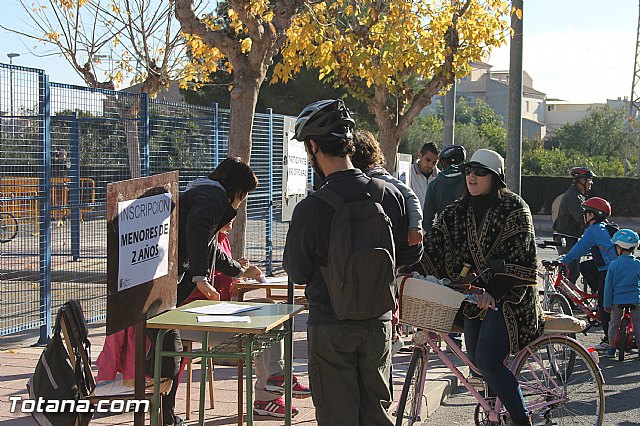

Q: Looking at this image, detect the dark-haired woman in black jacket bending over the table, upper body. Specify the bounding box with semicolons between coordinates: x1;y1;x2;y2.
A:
178;157;260;305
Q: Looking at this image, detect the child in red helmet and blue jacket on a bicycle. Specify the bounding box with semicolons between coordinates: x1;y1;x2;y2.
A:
560;197;618;351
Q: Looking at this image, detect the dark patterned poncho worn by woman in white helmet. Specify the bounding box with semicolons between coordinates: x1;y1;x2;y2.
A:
419;191;544;354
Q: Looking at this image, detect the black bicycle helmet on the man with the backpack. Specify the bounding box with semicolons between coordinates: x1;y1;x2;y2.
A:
295;99;356;142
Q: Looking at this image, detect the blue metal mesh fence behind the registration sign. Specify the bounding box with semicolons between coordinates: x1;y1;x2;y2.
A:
0;64;298;340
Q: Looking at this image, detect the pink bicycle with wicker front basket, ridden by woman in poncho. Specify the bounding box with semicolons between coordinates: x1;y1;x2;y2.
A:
395;277;605;426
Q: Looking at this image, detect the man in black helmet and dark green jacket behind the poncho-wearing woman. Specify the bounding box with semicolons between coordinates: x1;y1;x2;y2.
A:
422;145;467;233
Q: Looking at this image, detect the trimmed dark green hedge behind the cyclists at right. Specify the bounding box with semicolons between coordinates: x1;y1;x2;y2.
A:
521;176;640;217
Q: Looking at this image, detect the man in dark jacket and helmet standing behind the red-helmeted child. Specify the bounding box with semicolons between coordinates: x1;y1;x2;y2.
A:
553;166;596;283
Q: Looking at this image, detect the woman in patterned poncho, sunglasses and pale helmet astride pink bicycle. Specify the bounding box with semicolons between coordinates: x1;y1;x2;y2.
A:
420;149;543;425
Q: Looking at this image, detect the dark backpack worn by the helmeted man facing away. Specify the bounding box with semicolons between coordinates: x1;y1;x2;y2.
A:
311;179;396;320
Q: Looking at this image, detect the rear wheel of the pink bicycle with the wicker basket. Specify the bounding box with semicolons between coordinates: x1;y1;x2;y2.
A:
515;336;604;425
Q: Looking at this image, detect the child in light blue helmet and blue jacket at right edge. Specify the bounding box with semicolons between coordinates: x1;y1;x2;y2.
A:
603;229;640;358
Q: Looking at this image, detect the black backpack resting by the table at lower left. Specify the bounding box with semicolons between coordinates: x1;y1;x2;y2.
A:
27;300;95;426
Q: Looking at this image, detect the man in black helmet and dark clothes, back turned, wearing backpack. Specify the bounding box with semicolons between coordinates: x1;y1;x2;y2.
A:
283;100;422;426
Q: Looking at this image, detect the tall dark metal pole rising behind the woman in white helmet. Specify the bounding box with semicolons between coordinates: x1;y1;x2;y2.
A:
506;0;524;194
